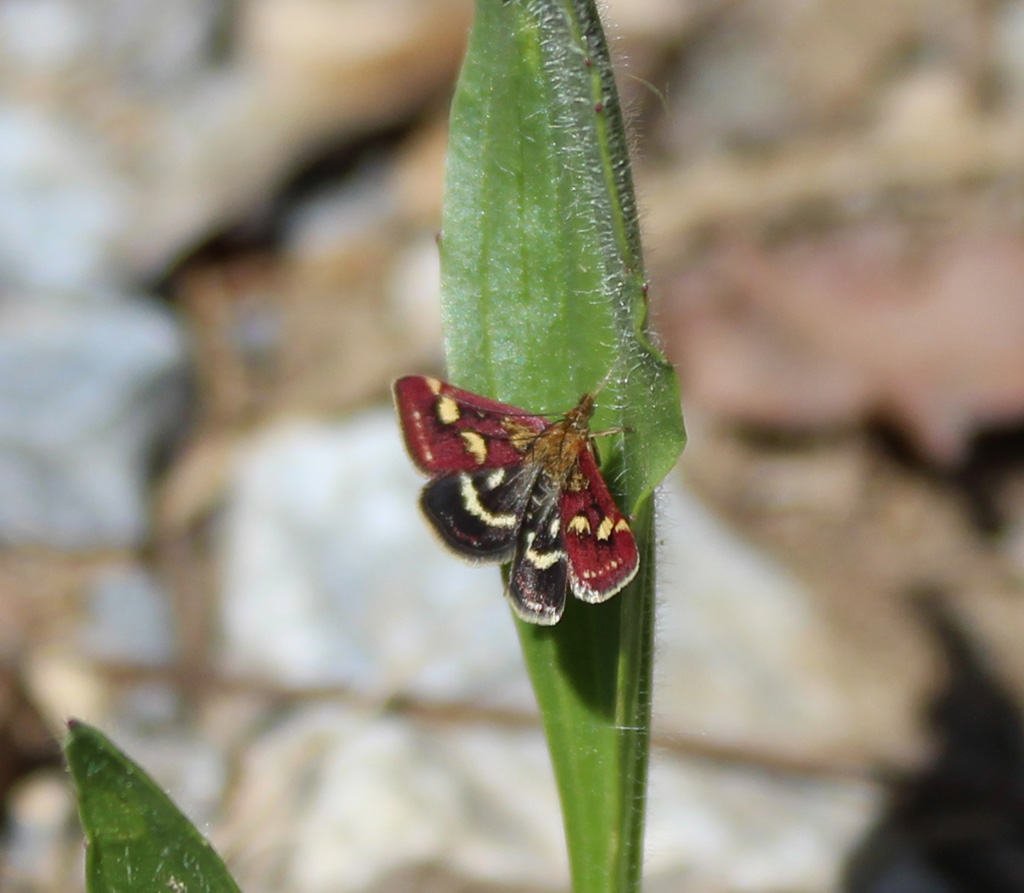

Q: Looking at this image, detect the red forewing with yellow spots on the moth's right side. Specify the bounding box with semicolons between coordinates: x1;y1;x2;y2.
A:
560;449;640;602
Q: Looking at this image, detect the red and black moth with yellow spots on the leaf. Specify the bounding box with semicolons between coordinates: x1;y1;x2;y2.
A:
393;375;640;626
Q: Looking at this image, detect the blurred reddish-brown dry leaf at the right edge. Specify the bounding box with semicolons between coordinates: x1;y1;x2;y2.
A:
665;221;1024;465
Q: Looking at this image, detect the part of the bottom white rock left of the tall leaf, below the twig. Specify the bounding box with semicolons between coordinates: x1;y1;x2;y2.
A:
219;705;567;893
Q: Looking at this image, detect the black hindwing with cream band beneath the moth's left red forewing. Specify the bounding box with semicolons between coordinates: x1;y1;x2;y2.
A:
420;463;538;564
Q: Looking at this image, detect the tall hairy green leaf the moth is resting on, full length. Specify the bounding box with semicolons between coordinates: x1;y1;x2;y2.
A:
441;0;685;893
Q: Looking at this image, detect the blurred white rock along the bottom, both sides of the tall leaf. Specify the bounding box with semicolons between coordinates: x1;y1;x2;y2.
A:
215;705;876;893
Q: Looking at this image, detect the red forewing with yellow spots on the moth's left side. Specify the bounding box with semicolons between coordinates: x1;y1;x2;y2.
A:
392;375;548;474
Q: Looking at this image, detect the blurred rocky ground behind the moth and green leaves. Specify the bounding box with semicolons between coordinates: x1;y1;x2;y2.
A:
0;0;1024;893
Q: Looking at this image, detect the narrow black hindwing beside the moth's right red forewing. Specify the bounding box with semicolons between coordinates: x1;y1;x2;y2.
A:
506;476;568;626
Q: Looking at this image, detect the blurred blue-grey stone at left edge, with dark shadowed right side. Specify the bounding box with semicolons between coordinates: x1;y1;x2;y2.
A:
0;297;186;550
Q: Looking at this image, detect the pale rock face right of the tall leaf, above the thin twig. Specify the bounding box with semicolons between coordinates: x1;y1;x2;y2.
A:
654;477;851;754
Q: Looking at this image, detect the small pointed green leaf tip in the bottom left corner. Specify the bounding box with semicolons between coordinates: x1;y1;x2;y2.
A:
65;721;240;893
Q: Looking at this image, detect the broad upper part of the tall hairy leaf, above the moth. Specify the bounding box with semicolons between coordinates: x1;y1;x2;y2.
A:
441;0;684;512
